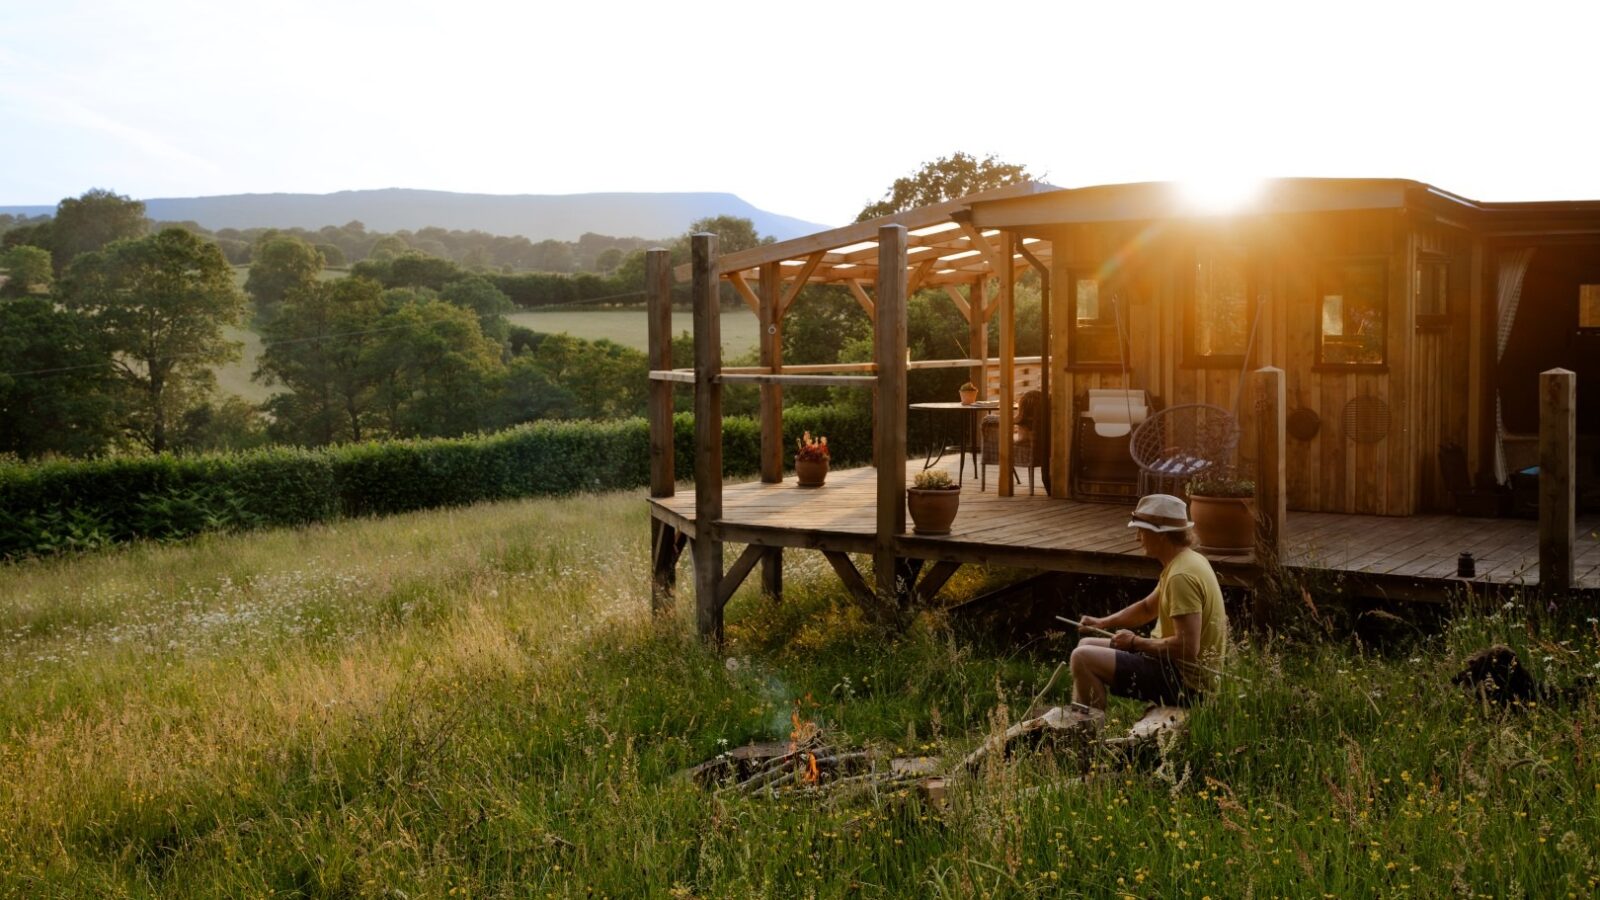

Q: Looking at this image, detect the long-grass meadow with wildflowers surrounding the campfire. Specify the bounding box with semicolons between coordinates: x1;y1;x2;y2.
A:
0;495;1600;897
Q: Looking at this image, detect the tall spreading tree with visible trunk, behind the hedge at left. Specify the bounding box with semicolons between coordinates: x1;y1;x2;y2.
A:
62;227;245;453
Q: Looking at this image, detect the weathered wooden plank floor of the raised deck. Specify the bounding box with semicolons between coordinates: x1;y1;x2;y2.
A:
650;468;1600;599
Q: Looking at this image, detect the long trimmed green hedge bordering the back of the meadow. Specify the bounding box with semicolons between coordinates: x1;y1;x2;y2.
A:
0;407;918;559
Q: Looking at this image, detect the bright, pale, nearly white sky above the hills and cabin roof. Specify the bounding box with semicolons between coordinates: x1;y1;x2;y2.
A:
0;0;1600;224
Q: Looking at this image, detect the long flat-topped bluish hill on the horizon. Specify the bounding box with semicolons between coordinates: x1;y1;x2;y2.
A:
0;187;830;240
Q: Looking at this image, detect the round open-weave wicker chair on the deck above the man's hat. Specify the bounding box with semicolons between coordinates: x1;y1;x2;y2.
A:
1128;404;1238;496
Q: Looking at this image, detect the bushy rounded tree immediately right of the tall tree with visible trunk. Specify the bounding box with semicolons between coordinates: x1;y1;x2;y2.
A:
254;277;389;445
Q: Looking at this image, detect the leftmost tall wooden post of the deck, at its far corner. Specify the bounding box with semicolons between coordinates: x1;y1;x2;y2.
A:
645;248;678;610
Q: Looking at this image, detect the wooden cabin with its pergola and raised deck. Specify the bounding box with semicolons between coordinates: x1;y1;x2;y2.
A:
648;179;1600;634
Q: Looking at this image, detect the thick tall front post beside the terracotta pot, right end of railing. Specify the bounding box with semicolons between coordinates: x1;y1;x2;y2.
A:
872;226;910;609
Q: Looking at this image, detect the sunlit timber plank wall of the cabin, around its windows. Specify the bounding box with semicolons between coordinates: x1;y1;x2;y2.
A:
1053;211;1420;516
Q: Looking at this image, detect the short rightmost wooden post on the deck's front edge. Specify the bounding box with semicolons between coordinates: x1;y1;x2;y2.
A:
1539;368;1578;593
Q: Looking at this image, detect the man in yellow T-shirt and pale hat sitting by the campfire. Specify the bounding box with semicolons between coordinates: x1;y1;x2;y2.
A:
1070;493;1227;709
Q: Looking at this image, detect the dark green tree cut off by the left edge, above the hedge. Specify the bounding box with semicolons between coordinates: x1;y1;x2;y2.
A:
0;298;115;458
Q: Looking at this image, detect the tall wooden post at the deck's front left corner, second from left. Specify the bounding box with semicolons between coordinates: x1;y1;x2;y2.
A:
690;234;722;644
